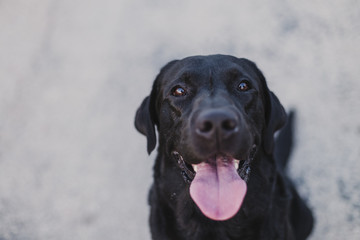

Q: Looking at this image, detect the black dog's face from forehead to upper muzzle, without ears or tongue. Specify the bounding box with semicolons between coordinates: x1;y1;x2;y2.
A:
157;57;264;164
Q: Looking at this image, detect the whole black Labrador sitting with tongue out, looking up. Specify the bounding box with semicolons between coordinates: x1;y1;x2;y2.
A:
135;55;313;240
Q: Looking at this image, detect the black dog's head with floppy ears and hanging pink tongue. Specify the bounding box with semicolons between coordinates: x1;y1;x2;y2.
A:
135;55;286;220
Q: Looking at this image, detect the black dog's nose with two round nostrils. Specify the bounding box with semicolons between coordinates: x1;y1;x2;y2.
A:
195;109;239;140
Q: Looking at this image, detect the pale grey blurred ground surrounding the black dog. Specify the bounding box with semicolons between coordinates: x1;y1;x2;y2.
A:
0;0;360;240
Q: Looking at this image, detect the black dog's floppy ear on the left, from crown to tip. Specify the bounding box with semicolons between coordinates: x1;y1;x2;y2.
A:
135;60;176;154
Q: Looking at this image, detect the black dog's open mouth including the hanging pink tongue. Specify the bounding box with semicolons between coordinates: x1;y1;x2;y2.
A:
172;145;256;221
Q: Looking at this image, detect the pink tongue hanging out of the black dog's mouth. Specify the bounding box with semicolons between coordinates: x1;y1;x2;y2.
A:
190;158;246;221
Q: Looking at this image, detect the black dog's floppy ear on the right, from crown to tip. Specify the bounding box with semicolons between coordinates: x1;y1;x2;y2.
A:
242;59;287;154
